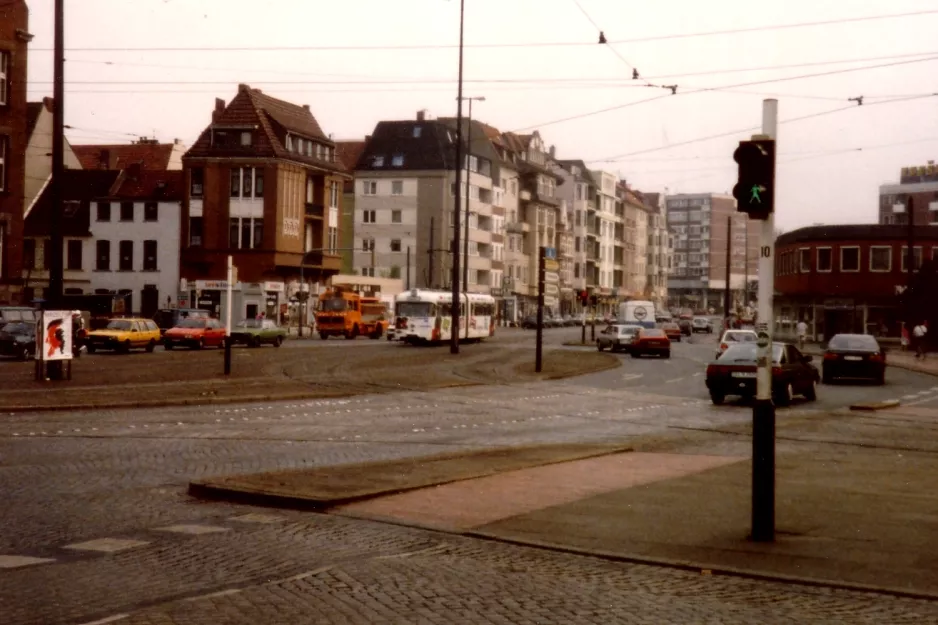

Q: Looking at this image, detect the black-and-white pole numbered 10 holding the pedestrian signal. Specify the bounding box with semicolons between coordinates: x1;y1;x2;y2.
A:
752;99;778;542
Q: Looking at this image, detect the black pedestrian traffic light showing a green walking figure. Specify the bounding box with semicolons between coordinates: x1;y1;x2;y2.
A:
733;139;775;219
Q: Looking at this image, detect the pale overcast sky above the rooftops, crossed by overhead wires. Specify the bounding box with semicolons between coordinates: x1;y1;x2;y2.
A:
18;0;938;230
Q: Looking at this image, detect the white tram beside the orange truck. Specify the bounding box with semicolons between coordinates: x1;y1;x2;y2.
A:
394;289;495;343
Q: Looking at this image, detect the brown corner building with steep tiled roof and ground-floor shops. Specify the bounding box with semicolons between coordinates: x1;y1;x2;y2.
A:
181;84;349;318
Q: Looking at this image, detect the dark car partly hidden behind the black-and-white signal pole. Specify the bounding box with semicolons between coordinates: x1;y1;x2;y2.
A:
706;341;820;406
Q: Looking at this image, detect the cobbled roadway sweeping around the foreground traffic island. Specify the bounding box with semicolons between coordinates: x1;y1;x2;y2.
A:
0;329;938;625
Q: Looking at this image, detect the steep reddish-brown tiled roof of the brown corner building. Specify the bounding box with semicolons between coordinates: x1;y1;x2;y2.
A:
184;84;346;172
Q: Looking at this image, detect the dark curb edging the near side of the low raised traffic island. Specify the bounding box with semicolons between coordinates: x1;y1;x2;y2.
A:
187;445;635;512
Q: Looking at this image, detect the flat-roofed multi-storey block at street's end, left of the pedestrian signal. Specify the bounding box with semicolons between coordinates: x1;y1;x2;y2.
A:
666;193;759;312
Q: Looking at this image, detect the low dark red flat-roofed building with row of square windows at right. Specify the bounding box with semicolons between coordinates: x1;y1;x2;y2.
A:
775;225;938;340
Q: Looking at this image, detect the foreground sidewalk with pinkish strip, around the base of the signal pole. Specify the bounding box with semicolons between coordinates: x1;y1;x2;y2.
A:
196;407;938;599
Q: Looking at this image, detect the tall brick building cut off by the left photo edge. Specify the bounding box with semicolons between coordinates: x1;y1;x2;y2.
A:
0;0;32;304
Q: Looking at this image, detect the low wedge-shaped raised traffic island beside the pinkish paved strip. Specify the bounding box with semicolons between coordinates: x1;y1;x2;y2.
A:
189;444;630;510
